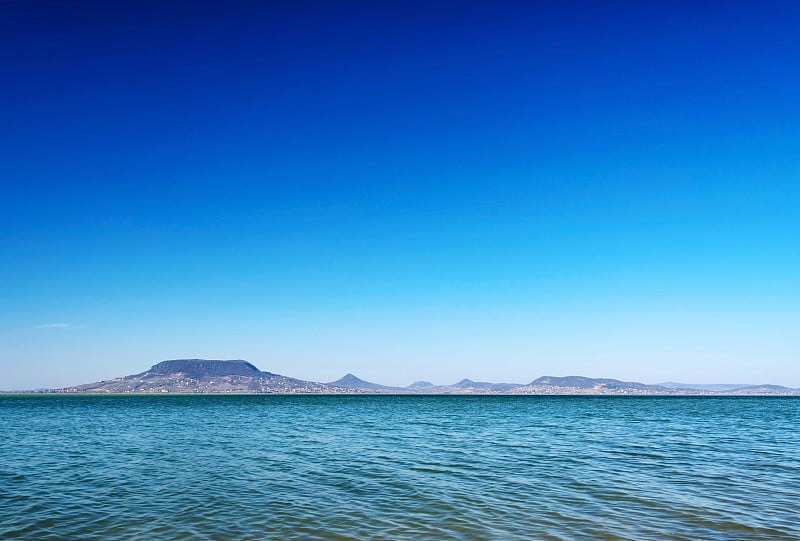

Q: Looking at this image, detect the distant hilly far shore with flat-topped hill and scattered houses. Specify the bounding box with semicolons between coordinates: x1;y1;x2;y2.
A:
15;359;800;396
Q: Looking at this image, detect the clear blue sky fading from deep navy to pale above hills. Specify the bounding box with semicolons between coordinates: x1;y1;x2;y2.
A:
0;0;800;389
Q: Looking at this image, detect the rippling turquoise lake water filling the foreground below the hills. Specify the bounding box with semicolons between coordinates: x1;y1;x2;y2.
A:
0;396;800;541
